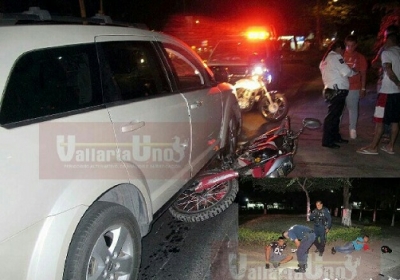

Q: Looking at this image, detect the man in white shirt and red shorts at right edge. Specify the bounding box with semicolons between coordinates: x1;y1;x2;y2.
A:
357;33;400;155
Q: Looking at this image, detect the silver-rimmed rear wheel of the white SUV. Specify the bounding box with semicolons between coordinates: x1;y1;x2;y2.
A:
63;202;141;280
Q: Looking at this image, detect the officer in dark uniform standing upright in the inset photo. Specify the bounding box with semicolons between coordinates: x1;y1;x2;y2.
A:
310;200;332;256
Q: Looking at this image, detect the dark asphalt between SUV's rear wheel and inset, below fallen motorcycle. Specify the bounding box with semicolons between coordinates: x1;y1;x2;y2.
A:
139;203;238;280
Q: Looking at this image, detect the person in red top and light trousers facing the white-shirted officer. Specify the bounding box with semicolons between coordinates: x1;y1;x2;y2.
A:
344;35;368;139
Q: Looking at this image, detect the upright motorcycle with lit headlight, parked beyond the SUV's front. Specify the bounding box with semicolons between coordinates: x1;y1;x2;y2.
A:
234;62;289;121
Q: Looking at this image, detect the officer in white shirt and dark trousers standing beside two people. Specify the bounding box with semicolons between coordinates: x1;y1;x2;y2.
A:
319;40;358;149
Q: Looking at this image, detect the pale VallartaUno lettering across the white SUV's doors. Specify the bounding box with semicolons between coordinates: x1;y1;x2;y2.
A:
57;135;188;163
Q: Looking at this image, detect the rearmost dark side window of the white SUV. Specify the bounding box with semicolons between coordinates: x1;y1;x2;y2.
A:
0;44;102;125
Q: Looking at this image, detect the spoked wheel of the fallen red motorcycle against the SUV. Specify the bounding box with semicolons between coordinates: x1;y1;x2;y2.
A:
169;169;239;222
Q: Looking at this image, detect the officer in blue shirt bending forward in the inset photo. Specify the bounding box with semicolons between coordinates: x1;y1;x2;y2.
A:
283;225;315;273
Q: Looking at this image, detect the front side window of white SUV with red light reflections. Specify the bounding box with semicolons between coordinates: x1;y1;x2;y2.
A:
163;43;205;91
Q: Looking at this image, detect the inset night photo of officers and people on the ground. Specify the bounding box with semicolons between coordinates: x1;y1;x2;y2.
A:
238;178;400;280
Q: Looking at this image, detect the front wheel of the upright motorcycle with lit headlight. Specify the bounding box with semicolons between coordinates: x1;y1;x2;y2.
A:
258;93;289;122
